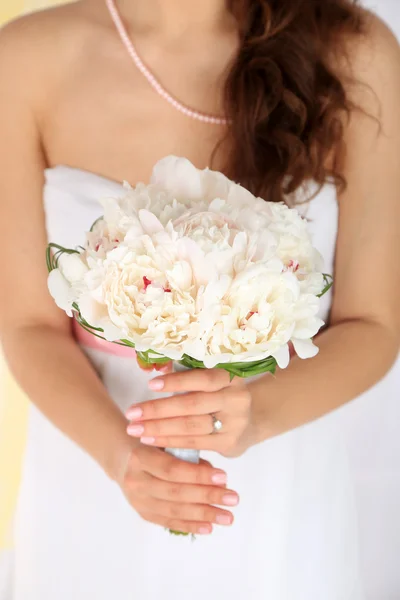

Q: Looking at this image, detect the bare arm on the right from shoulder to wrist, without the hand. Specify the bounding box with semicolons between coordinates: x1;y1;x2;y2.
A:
252;12;400;437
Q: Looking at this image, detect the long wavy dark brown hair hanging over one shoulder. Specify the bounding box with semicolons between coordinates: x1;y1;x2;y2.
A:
225;0;364;201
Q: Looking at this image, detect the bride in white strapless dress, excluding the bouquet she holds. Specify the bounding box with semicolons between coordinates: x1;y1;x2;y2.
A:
0;0;400;600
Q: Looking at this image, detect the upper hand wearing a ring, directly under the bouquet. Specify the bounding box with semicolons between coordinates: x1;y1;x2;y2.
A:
126;369;257;457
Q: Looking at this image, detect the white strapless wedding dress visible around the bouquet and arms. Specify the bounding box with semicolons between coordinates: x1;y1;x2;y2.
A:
9;167;364;600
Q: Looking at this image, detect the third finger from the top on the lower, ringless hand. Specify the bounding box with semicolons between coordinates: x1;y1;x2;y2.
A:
146;498;233;525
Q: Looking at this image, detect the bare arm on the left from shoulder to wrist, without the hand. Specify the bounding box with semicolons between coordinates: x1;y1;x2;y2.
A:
0;24;132;478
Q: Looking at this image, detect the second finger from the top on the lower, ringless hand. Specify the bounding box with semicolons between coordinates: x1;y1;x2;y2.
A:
146;476;239;512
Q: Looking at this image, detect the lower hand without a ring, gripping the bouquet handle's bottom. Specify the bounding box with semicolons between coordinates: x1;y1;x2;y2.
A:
120;444;239;535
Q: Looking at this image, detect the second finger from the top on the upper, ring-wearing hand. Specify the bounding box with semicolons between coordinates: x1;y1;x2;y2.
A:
126;392;224;421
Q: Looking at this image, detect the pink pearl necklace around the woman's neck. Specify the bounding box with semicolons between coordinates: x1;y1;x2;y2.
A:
106;0;228;125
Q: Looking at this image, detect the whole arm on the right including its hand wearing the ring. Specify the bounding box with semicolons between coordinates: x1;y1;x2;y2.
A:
123;14;400;456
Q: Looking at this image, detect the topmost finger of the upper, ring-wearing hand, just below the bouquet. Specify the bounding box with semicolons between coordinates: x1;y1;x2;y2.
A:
149;369;230;392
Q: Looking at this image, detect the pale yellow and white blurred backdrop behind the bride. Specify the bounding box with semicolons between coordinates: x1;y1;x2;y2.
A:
0;0;400;600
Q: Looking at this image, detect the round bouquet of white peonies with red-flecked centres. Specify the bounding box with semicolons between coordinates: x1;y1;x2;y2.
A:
47;156;332;528
